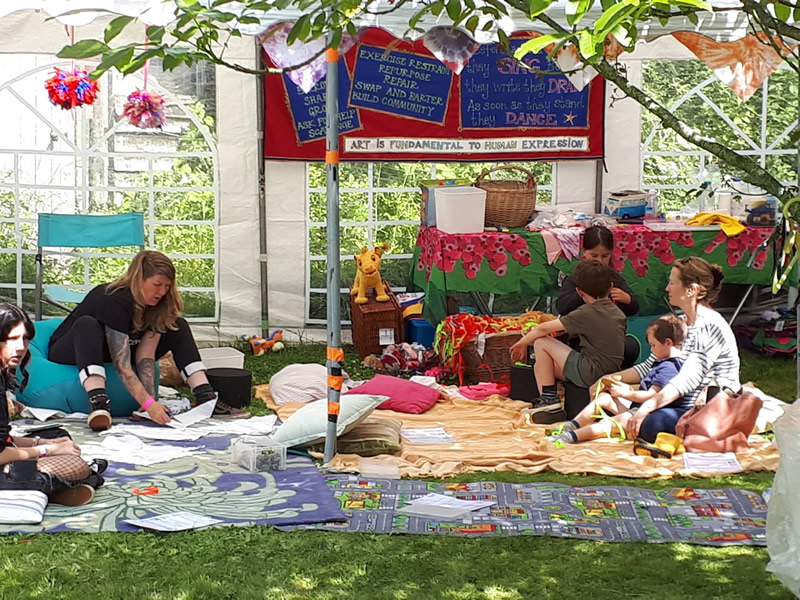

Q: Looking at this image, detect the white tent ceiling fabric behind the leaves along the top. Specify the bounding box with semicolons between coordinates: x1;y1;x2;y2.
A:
0;0;747;43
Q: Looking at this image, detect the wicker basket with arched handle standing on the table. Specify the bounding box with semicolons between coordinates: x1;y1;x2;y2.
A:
475;165;536;227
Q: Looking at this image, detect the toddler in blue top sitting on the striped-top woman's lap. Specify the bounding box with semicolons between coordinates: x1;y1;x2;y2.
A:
547;315;686;444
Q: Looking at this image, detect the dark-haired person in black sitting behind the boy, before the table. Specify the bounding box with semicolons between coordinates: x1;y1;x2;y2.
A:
556;225;639;317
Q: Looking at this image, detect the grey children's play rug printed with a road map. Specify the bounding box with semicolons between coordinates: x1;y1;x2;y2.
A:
281;475;767;546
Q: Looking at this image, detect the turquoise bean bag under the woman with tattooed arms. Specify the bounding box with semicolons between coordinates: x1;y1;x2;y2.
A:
17;319;160;417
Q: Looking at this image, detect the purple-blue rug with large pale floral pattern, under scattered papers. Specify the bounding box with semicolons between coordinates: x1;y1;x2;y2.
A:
0;424;344;534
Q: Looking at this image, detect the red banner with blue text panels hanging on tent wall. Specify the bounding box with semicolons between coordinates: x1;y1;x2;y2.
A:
264;29;605;162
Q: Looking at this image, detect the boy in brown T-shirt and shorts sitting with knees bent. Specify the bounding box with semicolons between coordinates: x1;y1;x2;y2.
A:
511;261;627;424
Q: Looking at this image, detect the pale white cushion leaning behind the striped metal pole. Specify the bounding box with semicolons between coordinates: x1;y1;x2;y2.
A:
272;394;389;448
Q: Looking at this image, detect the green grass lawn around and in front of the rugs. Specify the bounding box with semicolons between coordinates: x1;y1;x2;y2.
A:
0;345;795;600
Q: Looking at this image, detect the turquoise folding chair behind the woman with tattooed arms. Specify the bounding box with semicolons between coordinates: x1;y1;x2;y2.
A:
35;212;145;321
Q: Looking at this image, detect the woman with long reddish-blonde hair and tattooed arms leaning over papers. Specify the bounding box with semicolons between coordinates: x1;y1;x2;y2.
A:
48;250;250;431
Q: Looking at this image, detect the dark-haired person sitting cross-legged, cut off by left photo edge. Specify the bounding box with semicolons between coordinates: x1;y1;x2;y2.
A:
0;304;102;506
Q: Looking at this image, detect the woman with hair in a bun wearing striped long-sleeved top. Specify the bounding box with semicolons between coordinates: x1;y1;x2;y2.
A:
596;256;741;442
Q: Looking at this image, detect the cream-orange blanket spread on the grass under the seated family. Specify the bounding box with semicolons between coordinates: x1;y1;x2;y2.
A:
255;385;778;478
